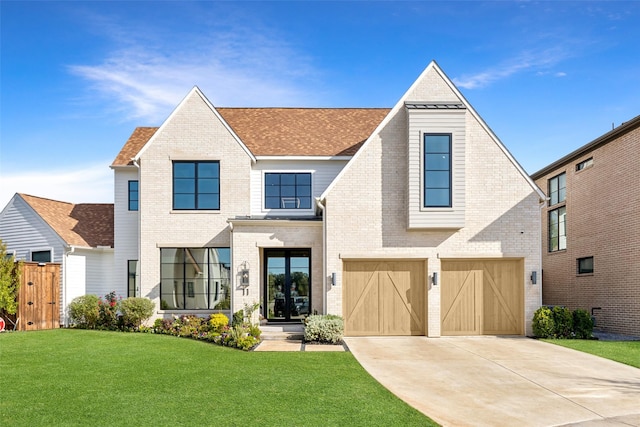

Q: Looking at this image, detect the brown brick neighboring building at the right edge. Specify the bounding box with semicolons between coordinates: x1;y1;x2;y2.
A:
531;116;640;336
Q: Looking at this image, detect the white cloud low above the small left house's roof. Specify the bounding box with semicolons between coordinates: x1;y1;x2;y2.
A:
0;161;113;210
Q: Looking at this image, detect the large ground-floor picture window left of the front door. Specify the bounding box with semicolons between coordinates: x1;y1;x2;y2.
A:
160;248;231;310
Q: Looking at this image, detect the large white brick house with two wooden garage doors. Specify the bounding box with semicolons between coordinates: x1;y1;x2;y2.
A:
111;62;545;337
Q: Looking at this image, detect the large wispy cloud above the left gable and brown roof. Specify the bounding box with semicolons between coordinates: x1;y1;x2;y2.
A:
69;21;315;123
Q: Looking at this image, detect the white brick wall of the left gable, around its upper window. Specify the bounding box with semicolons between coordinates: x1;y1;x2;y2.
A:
140;92;251;318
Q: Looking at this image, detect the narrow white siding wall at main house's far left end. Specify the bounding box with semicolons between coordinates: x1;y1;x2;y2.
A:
113;166;140;297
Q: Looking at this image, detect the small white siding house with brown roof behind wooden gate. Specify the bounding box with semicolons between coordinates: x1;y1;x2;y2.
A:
0;193;114;325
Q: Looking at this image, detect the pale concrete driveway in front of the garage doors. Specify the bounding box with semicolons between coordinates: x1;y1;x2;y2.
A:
345;337;640;426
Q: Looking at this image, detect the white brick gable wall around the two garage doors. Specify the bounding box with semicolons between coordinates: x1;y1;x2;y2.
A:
325;65;541;336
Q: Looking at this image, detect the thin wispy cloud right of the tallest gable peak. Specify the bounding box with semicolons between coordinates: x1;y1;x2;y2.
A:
453;48;566;89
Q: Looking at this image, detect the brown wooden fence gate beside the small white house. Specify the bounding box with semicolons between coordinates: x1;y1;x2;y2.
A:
17;262;60;331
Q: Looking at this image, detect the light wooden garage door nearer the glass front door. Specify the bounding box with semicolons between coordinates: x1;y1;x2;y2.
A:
342;260;426;336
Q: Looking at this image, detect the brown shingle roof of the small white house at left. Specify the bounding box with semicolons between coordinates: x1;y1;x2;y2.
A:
18;193;114;248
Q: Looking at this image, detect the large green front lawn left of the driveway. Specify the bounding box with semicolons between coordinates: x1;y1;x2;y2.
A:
0;329;437;426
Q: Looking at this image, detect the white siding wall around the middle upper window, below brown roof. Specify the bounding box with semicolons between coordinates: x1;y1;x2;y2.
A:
251;159;347;217
